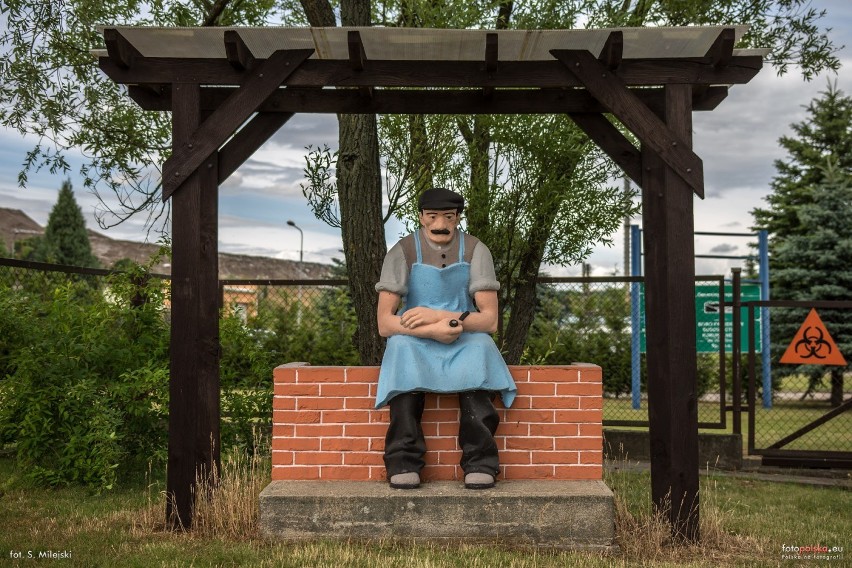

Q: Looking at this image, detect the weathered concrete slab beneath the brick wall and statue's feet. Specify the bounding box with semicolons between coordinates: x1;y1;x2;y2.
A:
260;480;615;549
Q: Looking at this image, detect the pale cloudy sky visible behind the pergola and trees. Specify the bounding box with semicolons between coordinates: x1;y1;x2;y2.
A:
0;0;852;276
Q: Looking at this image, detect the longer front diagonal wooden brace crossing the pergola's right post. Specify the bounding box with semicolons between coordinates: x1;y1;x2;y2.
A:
550;49;704;199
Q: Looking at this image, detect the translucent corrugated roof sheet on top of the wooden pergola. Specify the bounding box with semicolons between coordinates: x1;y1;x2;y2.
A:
95;26;747;61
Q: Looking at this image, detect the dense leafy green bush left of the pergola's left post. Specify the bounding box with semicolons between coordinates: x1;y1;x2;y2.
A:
0;266;168;487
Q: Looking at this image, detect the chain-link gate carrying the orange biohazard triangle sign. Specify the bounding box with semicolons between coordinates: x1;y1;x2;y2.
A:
743;301;852;458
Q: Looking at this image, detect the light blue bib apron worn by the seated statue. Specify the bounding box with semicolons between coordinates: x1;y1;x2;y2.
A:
376;231;517;408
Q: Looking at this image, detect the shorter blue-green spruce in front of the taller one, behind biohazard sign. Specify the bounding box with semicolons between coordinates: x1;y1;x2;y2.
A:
770;160;852;407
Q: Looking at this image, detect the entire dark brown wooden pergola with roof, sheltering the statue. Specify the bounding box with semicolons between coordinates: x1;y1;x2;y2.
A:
96;27;766;539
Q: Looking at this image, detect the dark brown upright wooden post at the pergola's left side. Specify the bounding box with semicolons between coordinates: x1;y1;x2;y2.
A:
166;83;219;528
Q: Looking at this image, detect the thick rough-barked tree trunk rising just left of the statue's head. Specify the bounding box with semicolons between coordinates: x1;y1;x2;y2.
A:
301;0;387;365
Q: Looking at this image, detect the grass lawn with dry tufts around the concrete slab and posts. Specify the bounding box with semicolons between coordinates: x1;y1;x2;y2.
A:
0;458;852;568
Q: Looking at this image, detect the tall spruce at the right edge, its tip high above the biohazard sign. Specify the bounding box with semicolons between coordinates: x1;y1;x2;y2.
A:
752;83;852;405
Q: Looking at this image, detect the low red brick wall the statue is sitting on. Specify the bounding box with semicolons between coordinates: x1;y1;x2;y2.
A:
272;364;603;480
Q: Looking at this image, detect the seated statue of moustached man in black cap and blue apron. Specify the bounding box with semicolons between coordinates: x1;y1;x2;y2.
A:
376;188;517;489
